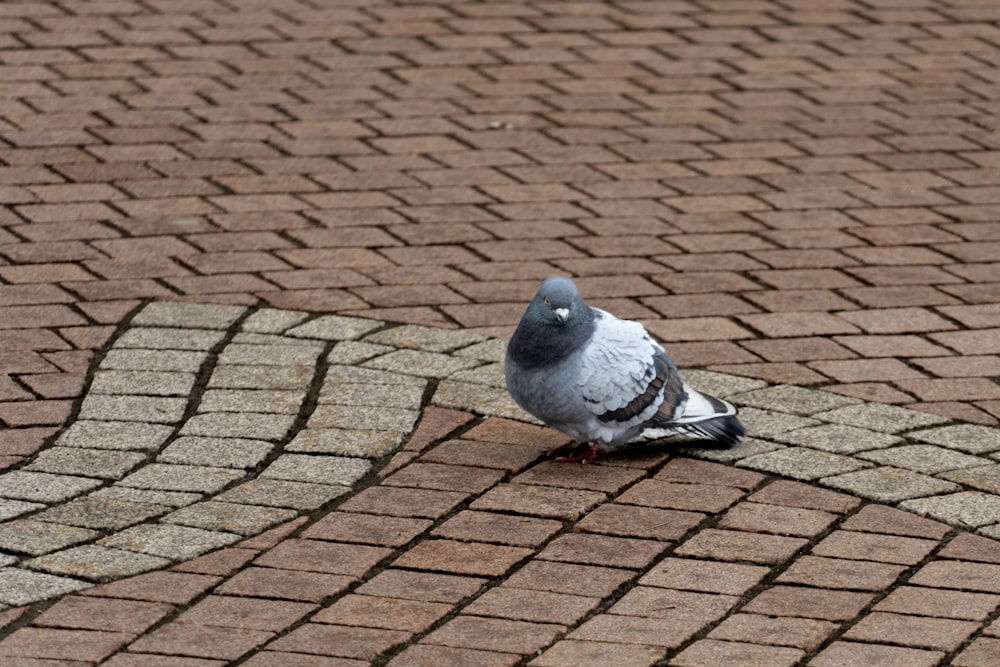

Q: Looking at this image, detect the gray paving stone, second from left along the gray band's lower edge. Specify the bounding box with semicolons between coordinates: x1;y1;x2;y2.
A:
24;544;170;582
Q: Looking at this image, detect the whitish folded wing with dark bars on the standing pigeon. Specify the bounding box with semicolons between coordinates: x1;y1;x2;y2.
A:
578;308;685;428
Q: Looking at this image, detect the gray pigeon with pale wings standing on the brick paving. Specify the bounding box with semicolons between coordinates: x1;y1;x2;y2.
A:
504;277;746;463
